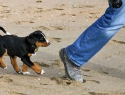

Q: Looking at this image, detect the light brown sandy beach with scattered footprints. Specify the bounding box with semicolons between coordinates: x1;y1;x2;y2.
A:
0;0;125;95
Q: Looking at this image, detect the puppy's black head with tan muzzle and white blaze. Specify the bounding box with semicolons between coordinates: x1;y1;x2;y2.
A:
27;30;50;47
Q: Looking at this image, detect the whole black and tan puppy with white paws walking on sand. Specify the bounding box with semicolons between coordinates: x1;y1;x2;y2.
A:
0;27;50;74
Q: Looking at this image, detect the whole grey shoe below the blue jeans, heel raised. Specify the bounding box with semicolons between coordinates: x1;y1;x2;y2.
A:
59;48;83;82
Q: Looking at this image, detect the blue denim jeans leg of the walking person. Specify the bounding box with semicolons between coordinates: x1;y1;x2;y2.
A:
66;0;125;66
